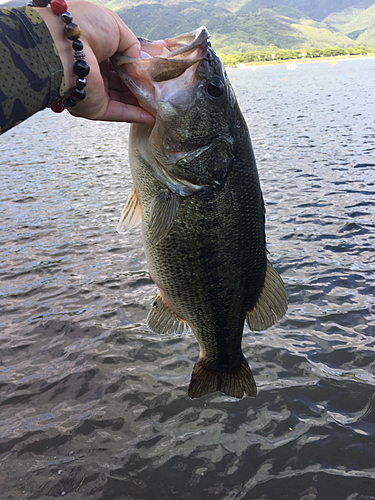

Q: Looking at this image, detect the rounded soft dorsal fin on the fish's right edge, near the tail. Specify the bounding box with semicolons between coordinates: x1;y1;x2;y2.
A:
246;260;288;332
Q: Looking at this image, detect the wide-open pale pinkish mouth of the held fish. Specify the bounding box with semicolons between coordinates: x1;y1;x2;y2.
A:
111;26;210;116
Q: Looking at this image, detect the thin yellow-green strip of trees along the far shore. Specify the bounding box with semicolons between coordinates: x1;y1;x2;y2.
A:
219;45;375;67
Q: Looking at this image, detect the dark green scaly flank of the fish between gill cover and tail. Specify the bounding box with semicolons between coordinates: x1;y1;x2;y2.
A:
131;126;266;352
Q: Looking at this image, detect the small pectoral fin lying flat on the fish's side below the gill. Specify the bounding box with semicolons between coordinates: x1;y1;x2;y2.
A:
147;189;180;245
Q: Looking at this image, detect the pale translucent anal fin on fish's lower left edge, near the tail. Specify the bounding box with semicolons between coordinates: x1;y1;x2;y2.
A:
147;290;189;333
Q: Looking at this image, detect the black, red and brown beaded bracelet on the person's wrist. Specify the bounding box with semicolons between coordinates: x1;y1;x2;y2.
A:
31;0;90;113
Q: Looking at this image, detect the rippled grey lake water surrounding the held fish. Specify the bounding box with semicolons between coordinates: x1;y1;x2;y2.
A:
0;60;375;500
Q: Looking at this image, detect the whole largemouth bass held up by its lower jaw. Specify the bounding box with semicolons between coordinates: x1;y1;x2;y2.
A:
111;26;288;399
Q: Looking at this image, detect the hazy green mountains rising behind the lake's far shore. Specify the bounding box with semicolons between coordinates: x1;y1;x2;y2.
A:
4;0;375;50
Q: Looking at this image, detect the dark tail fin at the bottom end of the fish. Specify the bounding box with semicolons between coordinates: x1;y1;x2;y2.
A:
188;358;257;399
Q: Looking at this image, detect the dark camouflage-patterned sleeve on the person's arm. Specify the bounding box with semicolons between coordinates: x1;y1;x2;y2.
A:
0;7;65;133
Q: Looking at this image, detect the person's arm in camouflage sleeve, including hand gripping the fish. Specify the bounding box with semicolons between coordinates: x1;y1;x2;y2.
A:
0;0;155;132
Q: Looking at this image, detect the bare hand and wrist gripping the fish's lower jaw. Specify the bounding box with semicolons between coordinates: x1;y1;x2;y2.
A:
35;0;155;124
